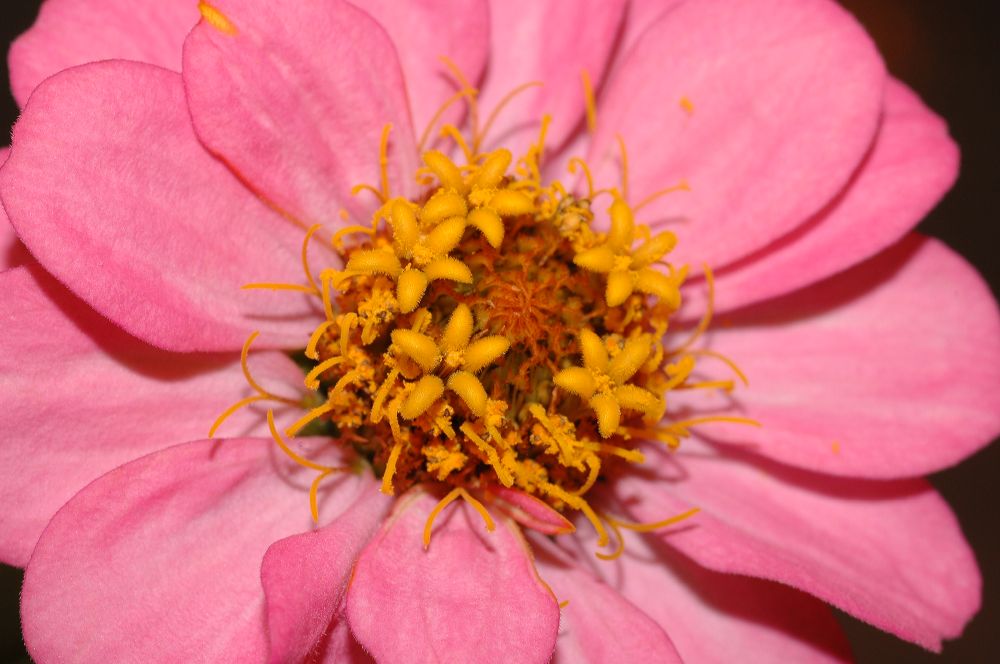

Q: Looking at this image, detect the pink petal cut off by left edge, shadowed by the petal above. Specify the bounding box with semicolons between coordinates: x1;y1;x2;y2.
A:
0;267;302;567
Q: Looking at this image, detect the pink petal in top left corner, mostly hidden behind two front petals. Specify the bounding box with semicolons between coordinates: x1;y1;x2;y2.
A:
7;0;198;107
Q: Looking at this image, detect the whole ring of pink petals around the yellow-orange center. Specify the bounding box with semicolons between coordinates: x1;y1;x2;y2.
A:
0;0;1000;662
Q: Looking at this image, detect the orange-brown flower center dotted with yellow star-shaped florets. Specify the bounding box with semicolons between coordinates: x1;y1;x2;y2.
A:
213;78;756;546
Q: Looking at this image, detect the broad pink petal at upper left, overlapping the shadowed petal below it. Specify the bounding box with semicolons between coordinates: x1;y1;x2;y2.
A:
0;61;317;350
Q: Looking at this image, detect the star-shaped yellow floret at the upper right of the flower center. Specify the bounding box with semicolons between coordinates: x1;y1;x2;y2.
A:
573;197;686;309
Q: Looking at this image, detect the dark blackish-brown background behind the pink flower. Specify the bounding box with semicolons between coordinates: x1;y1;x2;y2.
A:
0;0;1000;664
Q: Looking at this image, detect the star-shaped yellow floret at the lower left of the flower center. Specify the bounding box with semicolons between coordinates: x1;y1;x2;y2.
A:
384;304;510;420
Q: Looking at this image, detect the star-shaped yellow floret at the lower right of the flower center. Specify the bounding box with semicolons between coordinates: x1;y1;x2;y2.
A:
554;330;663;438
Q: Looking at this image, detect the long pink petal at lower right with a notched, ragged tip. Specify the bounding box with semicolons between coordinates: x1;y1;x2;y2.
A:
616;441;981;650
